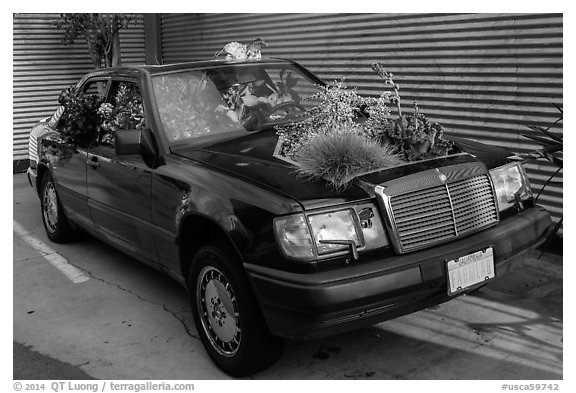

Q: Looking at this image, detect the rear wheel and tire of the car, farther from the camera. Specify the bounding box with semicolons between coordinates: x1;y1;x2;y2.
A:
40;173;77;243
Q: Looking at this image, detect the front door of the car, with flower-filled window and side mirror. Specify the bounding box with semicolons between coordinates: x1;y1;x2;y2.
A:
86;80;156;264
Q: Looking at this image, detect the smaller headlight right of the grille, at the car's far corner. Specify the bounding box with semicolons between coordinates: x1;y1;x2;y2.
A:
490;163;532;211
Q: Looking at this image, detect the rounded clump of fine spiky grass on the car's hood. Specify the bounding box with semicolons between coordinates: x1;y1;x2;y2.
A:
296;128;403;190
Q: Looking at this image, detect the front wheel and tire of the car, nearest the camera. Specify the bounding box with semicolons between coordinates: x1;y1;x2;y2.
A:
189;242;283;377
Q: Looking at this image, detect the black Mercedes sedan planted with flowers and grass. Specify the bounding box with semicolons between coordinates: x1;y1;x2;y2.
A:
28;58;551;376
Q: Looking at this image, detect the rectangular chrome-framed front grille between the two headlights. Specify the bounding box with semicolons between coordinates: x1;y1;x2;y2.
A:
386;174;498;252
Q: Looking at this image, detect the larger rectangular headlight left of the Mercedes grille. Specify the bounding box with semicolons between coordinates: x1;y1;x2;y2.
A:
274;203;389;261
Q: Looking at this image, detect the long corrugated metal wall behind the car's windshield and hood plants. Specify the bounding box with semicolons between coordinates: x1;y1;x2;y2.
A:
161;14;563;218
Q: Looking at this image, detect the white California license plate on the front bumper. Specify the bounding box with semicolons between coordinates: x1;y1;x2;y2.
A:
446;247;496;295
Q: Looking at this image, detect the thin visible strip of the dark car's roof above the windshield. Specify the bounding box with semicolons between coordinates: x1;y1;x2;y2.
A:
89;57;294;77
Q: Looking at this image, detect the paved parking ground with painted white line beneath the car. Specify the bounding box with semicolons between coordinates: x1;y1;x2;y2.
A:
13;174;564;380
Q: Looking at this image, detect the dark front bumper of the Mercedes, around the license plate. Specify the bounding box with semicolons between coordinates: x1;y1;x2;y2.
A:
246;207;552;338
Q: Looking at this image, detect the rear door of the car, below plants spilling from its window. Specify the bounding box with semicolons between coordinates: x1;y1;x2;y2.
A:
52;78;108;225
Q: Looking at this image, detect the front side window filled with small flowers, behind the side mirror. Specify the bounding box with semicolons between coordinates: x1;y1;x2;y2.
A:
98;81;146;147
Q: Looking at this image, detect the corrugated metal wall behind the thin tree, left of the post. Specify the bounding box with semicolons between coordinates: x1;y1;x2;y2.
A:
12;14;145;167
